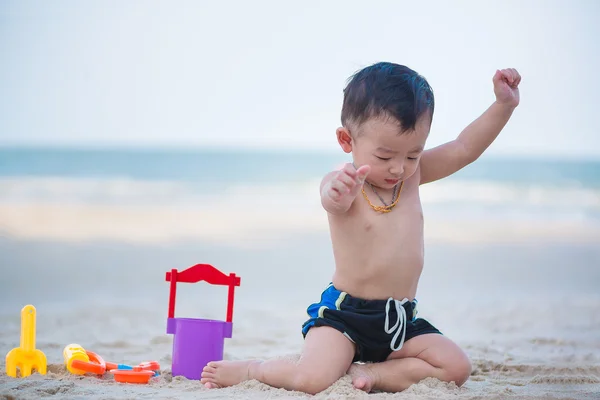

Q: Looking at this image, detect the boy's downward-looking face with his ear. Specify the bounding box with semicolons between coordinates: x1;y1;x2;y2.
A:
337;115;431;189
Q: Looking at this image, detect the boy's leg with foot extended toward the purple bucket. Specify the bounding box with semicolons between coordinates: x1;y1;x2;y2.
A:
201;326;355;394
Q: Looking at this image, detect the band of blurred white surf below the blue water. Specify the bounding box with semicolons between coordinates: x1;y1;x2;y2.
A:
0;177;600;212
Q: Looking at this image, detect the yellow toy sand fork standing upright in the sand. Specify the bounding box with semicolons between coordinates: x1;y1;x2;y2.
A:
6;305;47;378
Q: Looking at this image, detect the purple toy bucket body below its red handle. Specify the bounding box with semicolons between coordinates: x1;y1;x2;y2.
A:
167;318;233;380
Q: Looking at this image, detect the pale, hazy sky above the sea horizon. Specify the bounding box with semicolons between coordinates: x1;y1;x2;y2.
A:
0;0;600;158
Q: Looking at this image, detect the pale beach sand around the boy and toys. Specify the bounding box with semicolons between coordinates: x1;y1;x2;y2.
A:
0;205;600;400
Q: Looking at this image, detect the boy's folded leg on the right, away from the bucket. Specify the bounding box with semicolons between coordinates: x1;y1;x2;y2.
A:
348;333;471;392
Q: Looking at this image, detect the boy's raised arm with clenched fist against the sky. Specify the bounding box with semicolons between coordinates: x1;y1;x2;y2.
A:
420;69;521;184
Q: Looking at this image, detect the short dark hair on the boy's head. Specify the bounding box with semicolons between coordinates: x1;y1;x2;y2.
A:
342;62;435;131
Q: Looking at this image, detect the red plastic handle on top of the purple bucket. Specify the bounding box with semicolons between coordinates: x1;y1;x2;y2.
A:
166;264;241;322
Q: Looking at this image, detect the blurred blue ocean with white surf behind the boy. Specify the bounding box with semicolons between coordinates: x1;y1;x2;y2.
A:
0;148;600;223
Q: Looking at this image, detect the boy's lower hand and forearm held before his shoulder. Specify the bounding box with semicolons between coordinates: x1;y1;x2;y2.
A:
321;164;371;212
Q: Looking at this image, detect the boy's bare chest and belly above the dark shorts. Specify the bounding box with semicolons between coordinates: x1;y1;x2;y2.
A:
330;180;424;298
